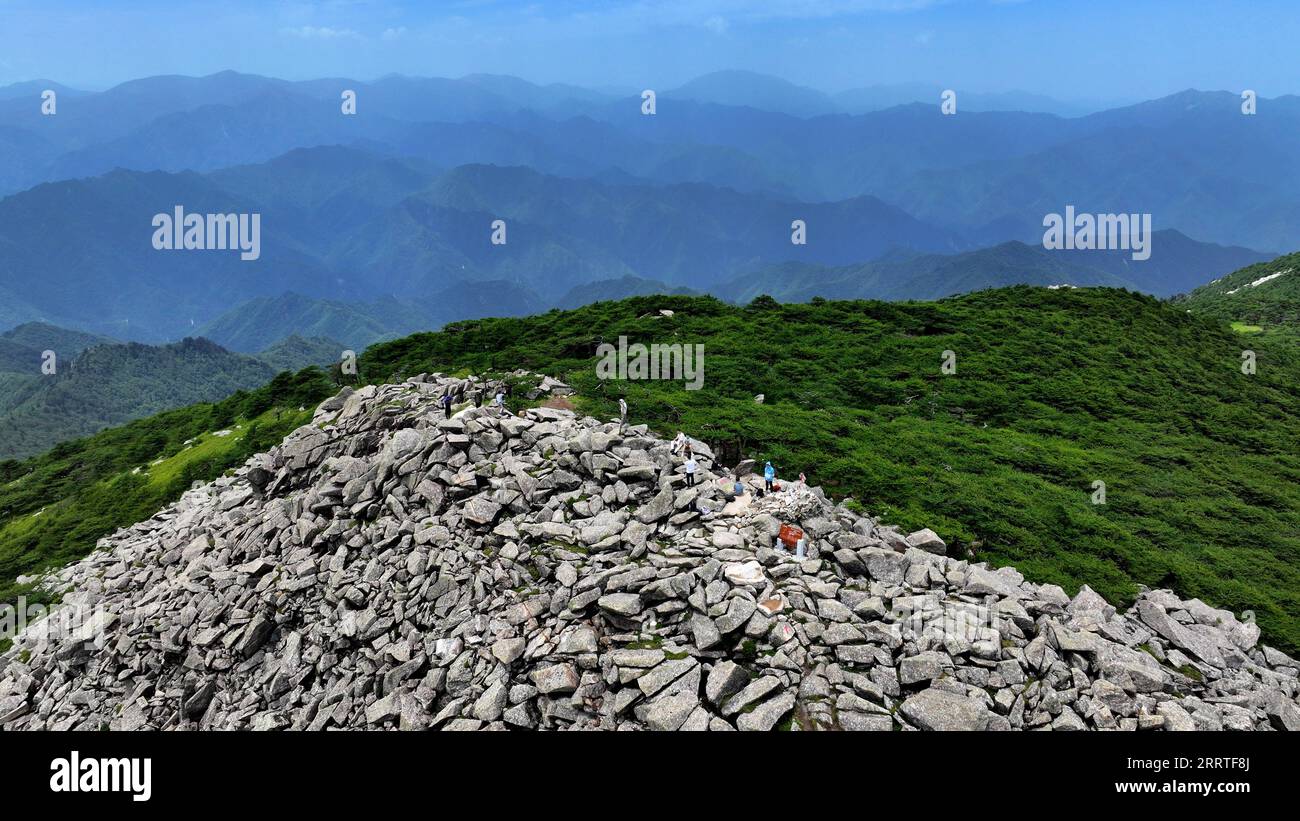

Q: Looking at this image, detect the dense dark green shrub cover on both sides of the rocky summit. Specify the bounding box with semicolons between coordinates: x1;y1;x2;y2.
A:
0;286;1300;652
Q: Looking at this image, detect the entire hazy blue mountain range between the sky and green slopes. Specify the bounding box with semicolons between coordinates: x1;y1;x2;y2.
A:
0;71;1300;353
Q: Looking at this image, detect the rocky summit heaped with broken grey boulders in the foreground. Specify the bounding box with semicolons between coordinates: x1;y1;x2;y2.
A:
0;374;1300;730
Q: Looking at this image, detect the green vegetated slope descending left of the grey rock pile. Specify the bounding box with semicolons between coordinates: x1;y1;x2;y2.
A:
0;368;335;615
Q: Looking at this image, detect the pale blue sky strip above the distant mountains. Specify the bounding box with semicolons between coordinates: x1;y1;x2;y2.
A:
0;0;1300;101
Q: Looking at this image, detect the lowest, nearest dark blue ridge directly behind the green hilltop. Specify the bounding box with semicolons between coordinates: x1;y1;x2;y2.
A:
202;231;1266;351
